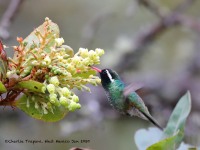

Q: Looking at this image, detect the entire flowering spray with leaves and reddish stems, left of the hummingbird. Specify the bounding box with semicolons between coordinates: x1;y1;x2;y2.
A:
0;18;104;122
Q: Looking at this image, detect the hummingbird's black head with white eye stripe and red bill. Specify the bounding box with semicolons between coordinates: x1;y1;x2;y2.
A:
91;67;120;87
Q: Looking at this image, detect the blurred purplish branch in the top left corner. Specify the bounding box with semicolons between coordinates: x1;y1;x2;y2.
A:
0;0;23;39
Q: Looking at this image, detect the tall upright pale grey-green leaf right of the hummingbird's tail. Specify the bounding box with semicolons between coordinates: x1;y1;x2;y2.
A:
164;92;191;146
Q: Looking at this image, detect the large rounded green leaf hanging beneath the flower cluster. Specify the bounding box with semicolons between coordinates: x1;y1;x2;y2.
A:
16;95;68;122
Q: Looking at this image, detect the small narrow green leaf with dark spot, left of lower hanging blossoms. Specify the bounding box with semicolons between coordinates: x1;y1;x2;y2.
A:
15;80;44;93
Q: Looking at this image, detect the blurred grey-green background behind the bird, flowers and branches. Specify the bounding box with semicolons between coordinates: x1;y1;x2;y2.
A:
0;0;200;150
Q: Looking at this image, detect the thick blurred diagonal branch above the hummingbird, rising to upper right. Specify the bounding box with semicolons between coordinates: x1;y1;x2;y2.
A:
115;0;195;72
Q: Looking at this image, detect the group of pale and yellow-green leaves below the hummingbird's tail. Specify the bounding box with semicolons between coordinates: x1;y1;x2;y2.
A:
135;92;195;150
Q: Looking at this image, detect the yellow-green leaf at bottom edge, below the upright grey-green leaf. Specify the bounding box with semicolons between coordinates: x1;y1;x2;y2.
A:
147;132;179;150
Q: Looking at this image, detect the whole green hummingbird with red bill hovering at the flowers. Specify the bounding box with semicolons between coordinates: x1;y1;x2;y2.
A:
91;66;163;130
